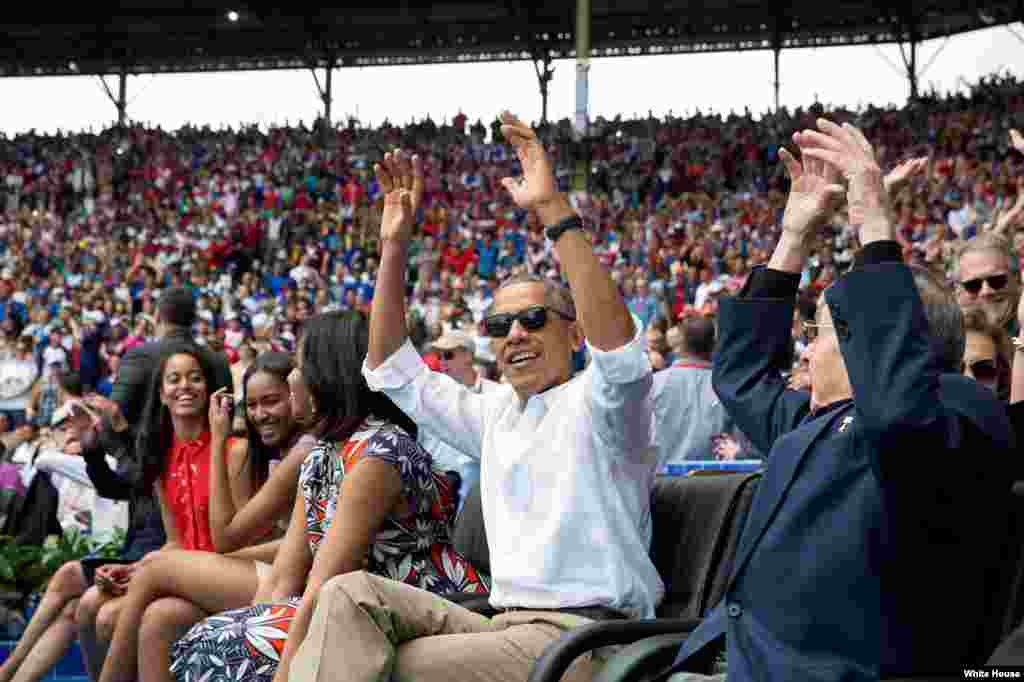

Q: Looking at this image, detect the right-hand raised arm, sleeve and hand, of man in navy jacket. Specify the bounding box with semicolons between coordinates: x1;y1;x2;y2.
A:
803;119;958;450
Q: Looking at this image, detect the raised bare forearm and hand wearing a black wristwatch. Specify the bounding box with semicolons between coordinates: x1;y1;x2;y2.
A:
502;112;636;350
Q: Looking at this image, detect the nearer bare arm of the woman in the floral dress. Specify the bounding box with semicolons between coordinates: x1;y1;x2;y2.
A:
273;459;401;682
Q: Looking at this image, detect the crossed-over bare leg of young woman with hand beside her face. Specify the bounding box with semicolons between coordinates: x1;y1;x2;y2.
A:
99;552;259;682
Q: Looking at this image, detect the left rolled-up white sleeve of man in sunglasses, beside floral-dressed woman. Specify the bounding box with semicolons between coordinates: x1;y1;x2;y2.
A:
362;339;484;458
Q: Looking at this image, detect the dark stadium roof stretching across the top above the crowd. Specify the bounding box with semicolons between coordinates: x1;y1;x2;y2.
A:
0;0;1024;77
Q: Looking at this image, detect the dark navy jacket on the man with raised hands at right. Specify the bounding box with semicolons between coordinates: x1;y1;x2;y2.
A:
677;243;1014;682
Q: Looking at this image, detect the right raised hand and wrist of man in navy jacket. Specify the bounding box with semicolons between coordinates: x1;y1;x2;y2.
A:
799;119;895;246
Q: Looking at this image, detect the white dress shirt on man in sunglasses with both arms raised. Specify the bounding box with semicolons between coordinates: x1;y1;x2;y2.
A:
364;321;665;617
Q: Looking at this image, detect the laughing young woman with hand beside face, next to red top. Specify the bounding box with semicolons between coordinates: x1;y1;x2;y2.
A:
100;352;314;680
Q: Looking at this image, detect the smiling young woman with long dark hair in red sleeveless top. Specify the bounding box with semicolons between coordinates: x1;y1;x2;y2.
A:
78;342;230;671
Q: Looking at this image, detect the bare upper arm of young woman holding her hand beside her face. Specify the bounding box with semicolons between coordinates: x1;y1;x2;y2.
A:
210;438;313;552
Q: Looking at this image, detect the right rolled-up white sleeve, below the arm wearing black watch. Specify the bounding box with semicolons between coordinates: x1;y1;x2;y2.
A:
587;316;653;457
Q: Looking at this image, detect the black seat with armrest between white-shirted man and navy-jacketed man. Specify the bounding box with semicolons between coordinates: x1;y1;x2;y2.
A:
529;473;761;682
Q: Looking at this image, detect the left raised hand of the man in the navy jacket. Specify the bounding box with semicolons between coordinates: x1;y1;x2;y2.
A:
779;133;845;241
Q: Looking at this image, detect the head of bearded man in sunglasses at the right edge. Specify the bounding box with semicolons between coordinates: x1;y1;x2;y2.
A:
956;233;1021;336
